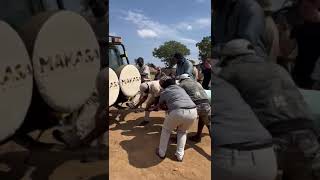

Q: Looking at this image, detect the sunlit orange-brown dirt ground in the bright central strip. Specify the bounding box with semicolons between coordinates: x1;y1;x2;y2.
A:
109;110;211;180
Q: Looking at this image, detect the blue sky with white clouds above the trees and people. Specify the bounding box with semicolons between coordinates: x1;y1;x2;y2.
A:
109;0;211;66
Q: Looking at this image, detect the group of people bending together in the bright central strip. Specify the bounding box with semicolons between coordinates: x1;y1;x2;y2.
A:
126;53;211;161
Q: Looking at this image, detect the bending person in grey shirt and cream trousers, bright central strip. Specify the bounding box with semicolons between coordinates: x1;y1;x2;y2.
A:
156;76;198;161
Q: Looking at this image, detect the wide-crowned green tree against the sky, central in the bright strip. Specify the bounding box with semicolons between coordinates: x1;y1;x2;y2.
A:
152;41;190;68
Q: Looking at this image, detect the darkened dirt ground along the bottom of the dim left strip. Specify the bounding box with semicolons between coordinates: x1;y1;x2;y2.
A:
0;130;108;180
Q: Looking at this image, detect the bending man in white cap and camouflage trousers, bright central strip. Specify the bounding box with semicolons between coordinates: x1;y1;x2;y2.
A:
179;74;211;142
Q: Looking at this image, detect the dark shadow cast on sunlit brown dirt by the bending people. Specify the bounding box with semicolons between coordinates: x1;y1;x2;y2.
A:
110;117;211;168
